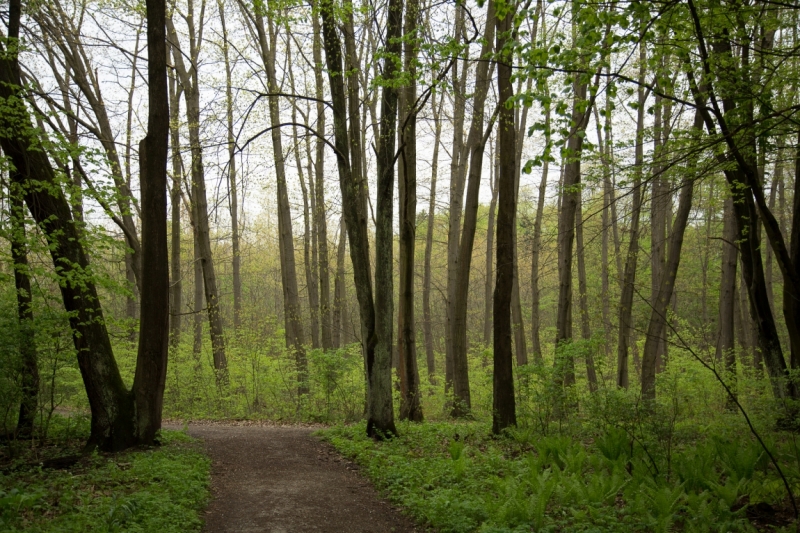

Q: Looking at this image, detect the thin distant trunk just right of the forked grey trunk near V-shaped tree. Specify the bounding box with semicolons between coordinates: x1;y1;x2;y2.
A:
217;0;242;330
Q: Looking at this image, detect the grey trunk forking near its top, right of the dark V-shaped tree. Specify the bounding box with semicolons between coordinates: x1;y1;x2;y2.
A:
167;16;228;374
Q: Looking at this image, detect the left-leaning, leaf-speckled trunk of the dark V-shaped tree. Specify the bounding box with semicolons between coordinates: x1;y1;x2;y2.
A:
0;16;135;450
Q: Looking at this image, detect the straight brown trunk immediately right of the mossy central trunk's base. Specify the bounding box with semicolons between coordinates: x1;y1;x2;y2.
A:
397;0;423;422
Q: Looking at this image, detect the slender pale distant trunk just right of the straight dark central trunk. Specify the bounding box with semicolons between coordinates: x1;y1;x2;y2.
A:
422;92;444;385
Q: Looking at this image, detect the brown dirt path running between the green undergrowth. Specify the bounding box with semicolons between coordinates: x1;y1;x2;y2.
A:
181;425;419;533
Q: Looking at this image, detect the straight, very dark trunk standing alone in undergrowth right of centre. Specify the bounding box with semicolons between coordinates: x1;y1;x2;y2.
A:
492;4;517;435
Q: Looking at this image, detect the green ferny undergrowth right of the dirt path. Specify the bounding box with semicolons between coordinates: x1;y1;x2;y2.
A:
320;422;797;533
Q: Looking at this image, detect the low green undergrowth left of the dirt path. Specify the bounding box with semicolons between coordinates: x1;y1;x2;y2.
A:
0;420;210;533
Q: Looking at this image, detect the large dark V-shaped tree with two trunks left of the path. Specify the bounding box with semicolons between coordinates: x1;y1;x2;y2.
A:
0;0;169;451
